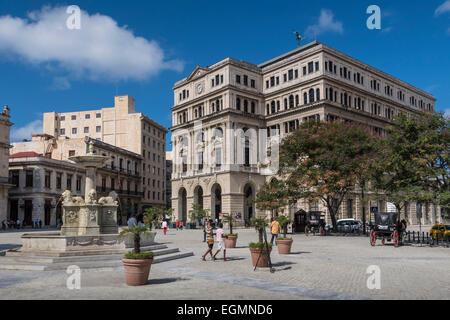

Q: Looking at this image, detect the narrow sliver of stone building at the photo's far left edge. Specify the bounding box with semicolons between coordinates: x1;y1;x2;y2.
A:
0;106;12;223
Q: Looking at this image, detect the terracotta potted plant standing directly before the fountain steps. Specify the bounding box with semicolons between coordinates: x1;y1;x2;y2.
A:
119;225;153;286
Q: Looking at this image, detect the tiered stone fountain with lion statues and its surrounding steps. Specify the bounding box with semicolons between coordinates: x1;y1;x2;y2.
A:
0;141;193;271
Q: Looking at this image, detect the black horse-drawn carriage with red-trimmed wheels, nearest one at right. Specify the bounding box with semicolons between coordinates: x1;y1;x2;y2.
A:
370;212;403;248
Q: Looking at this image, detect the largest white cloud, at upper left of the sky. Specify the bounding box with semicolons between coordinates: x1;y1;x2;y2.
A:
0;7;183;83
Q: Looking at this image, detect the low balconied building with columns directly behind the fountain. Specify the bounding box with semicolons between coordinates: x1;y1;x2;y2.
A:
9;134;143;226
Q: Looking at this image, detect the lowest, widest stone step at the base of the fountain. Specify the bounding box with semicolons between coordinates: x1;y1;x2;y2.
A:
0;249;194;271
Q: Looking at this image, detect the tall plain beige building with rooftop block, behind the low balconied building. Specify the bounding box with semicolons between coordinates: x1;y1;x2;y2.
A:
43;96;167;208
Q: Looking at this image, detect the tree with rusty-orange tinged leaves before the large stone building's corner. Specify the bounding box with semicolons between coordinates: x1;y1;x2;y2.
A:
280;121;380;230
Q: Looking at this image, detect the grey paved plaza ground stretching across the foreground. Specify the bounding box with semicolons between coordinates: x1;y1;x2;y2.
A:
0;229;450;300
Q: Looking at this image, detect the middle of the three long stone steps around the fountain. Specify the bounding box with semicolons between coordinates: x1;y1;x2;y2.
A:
0;246;179;264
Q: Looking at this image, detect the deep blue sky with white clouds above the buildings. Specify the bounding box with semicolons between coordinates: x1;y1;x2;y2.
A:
0;0;450;149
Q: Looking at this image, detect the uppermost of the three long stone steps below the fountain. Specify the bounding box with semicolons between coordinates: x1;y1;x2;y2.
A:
5;244;167;258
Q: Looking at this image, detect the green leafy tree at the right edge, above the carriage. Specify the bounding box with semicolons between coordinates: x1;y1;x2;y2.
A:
374;113;450;216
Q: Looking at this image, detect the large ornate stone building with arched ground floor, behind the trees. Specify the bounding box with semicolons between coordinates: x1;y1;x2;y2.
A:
171;41;439;228
